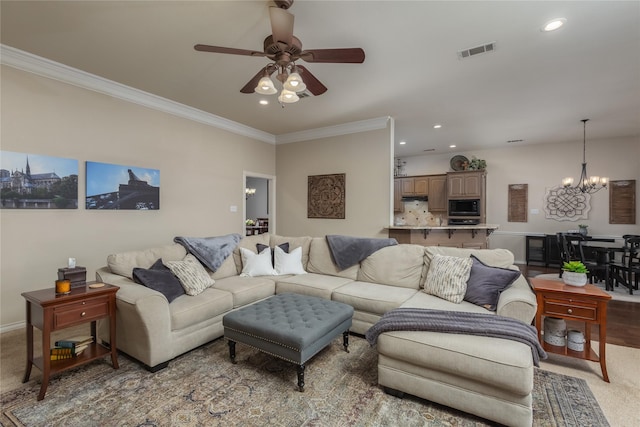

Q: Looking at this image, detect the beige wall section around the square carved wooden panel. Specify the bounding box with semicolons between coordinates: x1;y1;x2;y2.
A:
276;126;392;241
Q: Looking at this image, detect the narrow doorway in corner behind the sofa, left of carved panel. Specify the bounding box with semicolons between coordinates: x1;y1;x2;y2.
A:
244;172;275;236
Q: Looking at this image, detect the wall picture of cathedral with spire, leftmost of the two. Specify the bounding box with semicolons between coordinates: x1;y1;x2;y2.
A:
0;151;78;209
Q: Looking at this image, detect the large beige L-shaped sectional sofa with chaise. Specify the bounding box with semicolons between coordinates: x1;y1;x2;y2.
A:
96;234;536;426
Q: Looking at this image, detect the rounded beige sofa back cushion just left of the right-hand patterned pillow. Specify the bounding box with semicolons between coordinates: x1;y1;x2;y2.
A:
358;244;425;289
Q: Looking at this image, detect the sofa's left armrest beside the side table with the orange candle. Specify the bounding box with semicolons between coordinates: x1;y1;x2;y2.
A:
96;267;172;367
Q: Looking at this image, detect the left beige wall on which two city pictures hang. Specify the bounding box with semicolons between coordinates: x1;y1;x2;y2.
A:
0;66;275;327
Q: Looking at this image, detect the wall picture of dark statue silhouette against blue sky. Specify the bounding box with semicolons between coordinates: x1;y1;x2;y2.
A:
85;162;160;210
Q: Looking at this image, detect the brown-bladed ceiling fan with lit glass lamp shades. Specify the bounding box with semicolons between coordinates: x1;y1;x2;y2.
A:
194;0;364;103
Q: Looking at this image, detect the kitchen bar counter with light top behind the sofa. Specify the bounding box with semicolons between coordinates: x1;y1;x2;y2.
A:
386;224;499;249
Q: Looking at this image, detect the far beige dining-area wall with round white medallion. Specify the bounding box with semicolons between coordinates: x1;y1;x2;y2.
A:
403;138;640;261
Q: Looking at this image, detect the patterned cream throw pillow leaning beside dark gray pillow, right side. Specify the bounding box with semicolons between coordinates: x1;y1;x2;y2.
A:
424;255;473;304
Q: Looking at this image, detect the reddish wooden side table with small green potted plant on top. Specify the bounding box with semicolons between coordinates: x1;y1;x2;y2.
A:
529;277;611;382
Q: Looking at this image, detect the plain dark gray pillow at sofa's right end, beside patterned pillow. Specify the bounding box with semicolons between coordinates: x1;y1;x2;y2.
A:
464;255;520;311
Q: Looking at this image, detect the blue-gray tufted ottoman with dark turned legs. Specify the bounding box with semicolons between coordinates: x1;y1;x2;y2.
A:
222;293;353;391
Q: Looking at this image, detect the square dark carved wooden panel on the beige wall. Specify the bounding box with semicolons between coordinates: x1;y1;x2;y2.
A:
307;173;346;219
